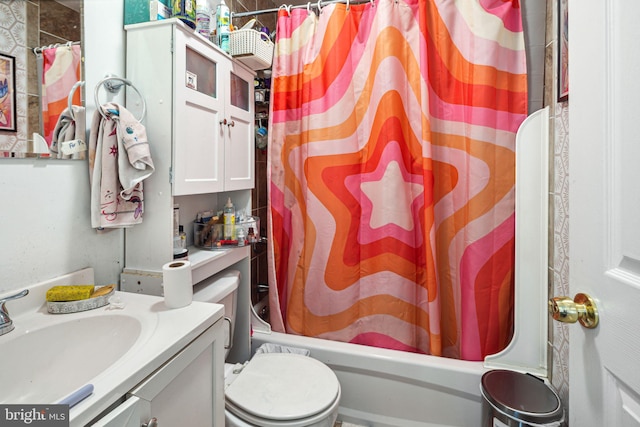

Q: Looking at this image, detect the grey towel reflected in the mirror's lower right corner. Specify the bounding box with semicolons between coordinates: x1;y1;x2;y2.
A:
50;105;87;159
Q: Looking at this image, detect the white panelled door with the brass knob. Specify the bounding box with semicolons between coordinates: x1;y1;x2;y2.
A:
569;0;640;427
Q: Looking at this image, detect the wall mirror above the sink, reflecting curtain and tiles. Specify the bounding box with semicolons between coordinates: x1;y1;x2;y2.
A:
0;0;86;159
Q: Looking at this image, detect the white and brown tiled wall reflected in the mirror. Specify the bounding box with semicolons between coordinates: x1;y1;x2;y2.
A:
0;0;82;151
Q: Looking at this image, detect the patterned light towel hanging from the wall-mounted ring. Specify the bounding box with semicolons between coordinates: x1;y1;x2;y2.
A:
89;103;154;229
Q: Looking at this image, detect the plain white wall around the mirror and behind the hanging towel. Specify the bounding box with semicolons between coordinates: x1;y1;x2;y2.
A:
0;0;125;294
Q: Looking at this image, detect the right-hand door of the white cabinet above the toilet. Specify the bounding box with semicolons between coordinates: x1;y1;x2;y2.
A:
224;63;255;191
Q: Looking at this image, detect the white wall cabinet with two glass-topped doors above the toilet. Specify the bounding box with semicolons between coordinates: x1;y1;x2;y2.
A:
125;19;255;196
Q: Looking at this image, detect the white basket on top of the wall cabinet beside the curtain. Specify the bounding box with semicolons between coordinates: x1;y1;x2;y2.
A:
229;29;273;71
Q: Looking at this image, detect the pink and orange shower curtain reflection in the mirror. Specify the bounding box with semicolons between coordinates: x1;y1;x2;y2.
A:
39;45;82;146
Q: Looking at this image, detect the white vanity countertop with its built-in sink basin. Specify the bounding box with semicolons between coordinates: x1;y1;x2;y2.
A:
0;268;223;427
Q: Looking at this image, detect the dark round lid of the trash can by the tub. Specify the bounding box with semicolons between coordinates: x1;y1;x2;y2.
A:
480;369;564;424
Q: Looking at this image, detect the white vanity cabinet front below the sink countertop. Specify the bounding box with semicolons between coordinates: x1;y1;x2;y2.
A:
91;321;224;427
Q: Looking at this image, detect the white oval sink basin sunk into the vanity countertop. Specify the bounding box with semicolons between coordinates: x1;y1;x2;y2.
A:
0;312;142;403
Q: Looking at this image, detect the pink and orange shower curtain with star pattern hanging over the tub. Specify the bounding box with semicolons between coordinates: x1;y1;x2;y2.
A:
268;0;527;360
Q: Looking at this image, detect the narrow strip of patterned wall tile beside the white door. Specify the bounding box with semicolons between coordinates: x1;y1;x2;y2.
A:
544;0;569;420
